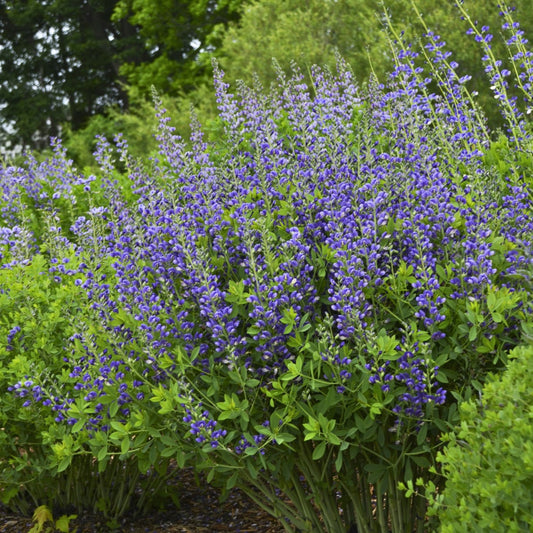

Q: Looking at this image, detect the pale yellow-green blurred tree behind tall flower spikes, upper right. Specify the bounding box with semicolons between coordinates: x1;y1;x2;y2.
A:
214;0;533;128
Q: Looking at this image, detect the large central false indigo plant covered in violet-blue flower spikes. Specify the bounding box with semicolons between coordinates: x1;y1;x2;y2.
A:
0;3;533;533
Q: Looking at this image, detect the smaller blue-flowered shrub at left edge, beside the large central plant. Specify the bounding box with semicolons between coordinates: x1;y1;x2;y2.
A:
0;144;176;518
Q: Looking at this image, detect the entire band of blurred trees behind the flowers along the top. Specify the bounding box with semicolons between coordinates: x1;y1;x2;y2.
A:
4;0;533;152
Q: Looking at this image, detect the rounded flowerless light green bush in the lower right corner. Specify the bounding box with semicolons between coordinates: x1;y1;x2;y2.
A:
437;346;533;533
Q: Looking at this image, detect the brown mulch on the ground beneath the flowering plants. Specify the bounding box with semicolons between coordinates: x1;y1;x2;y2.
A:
0;470;284;533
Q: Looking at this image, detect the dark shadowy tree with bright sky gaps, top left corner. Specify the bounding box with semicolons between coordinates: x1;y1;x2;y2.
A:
0;0;144;147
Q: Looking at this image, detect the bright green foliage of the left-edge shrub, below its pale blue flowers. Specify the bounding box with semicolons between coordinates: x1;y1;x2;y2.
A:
0;249;177;520
